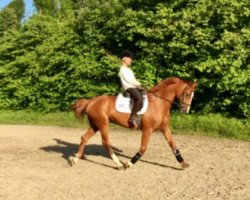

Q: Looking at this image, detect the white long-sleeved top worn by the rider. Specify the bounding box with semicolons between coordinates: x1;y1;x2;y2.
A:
119;65;141;90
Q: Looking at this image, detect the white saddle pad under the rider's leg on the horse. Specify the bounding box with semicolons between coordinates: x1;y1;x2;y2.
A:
115;93;148;115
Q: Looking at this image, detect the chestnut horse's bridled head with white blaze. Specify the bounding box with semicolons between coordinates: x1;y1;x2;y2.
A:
177;81;198;113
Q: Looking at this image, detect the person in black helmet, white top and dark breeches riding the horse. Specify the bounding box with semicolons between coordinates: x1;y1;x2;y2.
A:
119;50;142;126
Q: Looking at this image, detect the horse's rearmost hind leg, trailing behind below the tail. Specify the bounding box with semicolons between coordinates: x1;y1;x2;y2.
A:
70;127;98;166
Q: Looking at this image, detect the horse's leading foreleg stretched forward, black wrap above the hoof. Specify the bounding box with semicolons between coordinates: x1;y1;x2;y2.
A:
163;128;189;168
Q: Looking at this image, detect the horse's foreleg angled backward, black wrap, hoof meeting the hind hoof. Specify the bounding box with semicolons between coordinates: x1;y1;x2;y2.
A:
124;130;152;168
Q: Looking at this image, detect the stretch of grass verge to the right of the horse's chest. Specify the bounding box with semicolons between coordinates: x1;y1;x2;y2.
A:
171;111;250;141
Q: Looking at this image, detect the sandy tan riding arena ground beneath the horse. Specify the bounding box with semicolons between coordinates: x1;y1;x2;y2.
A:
0;125;250;200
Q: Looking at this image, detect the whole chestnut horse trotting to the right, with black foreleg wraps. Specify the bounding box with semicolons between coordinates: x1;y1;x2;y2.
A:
70;77;197;169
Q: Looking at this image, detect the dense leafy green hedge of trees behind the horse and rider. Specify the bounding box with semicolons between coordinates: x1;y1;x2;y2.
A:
0;0;250;118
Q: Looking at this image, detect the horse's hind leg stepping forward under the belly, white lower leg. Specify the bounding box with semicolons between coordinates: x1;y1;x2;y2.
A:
100;125;124;169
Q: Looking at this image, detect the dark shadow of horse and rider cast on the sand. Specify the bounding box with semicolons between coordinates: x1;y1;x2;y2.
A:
40;138;182;170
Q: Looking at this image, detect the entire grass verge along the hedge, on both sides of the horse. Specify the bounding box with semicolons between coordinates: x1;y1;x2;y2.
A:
0;110;250;141
